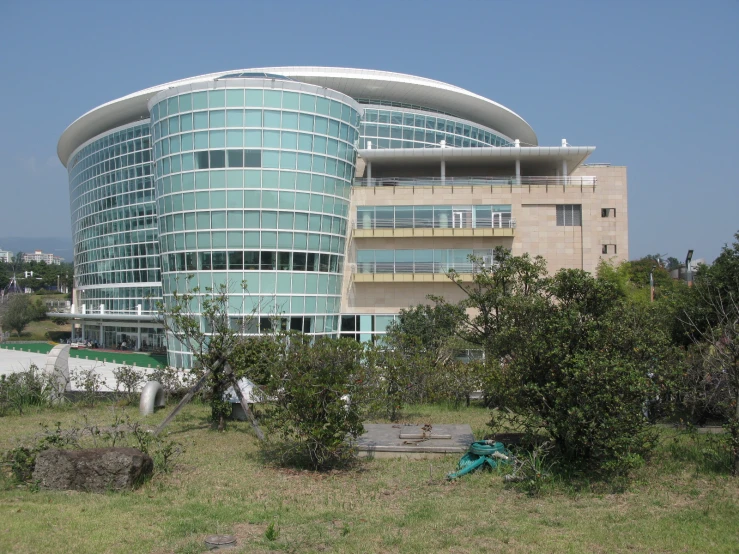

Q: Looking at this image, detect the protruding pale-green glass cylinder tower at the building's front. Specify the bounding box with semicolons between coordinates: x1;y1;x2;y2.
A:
149;78;360;366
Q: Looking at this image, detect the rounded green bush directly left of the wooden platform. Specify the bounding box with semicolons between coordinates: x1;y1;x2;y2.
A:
266;335;367;470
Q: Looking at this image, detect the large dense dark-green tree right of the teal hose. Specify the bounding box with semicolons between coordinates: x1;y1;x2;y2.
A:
451;252;672;472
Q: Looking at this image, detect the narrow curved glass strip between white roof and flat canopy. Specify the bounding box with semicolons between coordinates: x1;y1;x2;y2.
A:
360;106;513;148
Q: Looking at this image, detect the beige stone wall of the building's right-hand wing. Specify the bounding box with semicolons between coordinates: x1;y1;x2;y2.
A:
342;166;629;313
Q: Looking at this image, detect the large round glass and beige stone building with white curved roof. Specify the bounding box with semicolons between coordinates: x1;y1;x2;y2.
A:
58;67;628;367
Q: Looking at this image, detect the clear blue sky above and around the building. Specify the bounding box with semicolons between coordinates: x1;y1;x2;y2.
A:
0;0;739;262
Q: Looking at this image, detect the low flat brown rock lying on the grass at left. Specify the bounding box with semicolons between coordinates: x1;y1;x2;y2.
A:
33;448;154;492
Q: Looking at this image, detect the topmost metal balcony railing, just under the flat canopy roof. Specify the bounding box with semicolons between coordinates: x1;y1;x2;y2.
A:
354;175;598;187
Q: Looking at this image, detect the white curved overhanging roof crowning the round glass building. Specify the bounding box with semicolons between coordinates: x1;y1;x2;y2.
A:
57;66;538;166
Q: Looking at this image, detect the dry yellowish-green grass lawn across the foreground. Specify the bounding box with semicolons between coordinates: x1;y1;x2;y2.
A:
0;404;739;554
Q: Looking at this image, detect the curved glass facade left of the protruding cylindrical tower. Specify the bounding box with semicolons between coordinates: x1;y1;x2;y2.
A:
67;120;162;313
